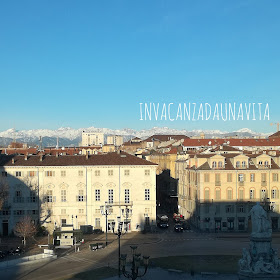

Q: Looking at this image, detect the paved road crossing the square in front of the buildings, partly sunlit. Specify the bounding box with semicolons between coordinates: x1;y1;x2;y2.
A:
0;229;280;280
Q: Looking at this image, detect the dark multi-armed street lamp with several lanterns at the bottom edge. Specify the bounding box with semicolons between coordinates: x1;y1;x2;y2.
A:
121;246;150;280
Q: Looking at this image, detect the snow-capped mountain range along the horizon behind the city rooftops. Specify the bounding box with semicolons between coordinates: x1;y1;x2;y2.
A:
0;127;272;147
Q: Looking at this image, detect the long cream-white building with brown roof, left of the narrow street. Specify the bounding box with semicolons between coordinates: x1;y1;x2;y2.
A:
0;153;157;235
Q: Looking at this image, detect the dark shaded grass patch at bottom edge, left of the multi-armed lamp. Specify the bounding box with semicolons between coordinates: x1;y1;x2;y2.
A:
61;267;118;280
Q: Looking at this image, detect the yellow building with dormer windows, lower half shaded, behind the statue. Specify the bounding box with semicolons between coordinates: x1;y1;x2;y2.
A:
176;153;280;231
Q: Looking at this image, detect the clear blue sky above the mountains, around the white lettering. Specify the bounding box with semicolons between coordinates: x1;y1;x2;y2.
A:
0;0;280;132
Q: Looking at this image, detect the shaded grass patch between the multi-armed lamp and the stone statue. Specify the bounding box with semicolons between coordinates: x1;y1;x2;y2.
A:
150;255;241;274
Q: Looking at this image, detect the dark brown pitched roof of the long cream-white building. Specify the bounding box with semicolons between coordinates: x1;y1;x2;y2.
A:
0;152;157;166
